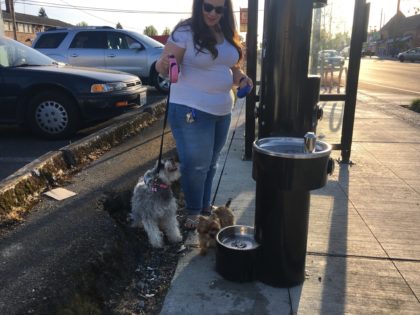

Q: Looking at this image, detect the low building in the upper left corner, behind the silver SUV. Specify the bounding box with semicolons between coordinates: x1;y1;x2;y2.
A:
1;0;73;45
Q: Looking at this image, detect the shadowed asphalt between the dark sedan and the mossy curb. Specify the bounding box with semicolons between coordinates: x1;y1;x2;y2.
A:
0;88;165;181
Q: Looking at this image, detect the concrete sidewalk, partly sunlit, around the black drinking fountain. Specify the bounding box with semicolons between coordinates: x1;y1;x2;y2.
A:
161;100;420;315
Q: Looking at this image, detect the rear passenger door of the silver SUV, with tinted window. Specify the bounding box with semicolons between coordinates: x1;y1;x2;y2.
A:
68;31;106;68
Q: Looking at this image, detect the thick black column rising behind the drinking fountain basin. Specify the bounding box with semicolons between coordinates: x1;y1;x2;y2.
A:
258;0;327;138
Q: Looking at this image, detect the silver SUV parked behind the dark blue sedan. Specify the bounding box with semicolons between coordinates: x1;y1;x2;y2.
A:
32;26;169;93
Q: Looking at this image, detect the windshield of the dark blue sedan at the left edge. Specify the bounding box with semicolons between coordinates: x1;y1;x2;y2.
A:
0;37;57;68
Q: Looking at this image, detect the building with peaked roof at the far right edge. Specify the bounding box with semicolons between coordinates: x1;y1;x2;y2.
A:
376;11;420;56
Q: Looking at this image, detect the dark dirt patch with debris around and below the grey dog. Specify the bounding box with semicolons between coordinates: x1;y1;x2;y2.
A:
56;191;188;314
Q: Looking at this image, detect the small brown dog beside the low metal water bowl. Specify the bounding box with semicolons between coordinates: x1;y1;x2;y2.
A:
197;199;235;255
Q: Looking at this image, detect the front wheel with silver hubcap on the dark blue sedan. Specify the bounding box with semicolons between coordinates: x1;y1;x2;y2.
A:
27;92;80;139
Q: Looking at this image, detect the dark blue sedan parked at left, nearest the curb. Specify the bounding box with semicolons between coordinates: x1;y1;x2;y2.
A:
0;37;147;139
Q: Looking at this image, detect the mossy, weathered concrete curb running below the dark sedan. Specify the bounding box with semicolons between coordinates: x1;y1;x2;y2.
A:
0;99;166;227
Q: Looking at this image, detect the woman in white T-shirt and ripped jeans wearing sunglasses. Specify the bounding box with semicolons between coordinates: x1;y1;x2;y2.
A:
156;0;253;229
